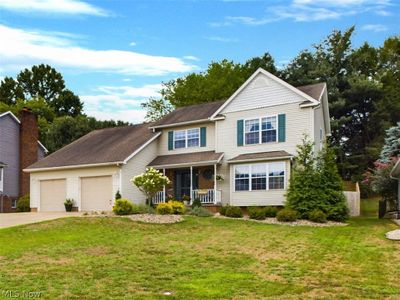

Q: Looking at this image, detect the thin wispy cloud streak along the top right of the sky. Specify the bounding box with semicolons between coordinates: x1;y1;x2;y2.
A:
210;0;391;27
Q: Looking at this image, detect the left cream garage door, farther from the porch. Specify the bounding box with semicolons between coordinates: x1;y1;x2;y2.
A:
40;179;66;211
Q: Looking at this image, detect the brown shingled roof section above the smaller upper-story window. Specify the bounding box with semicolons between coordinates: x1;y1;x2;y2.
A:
151;100;226;128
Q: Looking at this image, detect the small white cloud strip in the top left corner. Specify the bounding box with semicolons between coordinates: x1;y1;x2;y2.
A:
0;0;107;16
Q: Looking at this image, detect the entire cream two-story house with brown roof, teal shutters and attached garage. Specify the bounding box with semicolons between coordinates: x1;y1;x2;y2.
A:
26;69;330;211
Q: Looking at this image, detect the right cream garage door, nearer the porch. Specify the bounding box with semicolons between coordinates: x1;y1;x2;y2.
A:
81;176;113;211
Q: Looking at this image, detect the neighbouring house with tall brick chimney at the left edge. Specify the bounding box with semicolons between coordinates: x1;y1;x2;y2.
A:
0;109;47;212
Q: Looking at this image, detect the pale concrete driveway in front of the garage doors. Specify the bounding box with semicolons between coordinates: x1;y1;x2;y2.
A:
0;212;82;228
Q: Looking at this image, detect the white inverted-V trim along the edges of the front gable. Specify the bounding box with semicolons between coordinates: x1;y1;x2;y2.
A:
211;68;319;119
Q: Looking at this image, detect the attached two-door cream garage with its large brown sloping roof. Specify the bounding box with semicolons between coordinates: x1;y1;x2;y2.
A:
24;124;161;212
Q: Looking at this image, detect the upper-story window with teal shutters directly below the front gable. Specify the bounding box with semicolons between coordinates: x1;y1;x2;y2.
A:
244;116;278;145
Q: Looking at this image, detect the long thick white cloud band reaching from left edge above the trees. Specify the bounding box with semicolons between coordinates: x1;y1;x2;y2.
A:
0;24;197;76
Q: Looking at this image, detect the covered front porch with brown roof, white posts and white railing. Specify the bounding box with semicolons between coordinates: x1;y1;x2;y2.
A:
149;151;223;205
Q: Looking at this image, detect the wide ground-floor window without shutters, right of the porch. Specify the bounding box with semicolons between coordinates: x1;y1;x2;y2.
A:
235;162;286;191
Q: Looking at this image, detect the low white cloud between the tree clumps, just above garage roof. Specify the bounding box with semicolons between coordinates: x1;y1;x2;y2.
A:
80;84;161;123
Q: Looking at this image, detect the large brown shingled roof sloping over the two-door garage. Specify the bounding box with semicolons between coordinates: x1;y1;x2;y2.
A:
26;123;161;171
